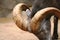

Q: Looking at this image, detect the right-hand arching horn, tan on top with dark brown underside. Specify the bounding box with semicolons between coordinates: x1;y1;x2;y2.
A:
31;7;60;32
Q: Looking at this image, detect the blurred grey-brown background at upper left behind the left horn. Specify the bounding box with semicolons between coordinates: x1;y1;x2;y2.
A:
0;0;34;17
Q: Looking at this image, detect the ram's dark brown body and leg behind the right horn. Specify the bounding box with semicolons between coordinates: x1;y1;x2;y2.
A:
30;0;60;39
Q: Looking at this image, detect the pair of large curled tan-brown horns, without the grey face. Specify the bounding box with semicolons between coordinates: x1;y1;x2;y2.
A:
13;3;60;32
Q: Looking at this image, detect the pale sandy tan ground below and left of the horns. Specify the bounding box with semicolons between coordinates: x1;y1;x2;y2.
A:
0;18;60;40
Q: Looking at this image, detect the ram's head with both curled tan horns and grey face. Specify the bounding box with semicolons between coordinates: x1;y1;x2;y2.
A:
13;3;60;40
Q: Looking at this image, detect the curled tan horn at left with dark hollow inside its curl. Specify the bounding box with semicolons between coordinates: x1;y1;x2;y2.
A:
13;3;29;30
